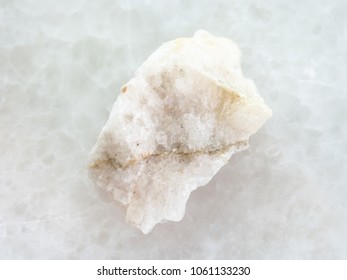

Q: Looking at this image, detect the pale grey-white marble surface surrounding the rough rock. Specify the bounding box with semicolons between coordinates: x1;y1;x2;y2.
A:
0;0;347;259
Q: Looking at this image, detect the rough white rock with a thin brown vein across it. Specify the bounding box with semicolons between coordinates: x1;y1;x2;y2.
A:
89;31;271;233
